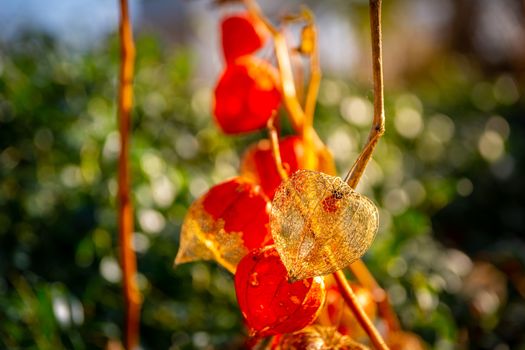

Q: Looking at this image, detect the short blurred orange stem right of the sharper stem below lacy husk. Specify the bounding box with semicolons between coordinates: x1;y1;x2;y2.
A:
350;259;401;332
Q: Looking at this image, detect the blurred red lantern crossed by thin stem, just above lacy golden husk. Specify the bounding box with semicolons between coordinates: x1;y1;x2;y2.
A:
241;136;304;199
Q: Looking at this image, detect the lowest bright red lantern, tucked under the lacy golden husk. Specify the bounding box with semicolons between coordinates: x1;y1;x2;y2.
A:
235;246;325;337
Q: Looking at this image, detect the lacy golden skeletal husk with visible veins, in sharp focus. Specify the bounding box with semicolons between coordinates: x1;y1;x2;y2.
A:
270;170;379;281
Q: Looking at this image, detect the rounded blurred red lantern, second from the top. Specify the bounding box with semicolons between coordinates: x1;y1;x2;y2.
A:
213;56;281;134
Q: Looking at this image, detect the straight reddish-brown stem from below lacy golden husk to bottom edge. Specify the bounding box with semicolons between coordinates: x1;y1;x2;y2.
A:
333;270;388;350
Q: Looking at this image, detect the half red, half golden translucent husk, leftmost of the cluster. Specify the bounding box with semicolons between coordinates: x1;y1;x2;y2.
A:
175;177;272;273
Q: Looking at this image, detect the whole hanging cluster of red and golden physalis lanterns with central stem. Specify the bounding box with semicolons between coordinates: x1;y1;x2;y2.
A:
175;1;426;349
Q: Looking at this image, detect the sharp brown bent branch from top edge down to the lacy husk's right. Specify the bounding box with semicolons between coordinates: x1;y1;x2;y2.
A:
345;0;385;188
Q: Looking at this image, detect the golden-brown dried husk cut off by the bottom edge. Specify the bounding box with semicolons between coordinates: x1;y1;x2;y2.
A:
272;326;368;350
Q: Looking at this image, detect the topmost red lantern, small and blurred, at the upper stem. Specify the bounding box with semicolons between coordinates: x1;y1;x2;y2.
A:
221;13;268;64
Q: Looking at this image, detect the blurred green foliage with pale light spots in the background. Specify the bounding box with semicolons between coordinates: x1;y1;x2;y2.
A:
0;23;525;349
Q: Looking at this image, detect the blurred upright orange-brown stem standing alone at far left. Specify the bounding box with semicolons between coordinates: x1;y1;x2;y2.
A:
117;0;141;350
